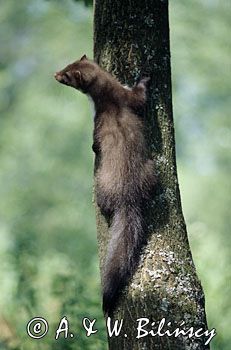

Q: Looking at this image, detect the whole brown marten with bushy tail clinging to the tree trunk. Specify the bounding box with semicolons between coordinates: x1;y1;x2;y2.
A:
55;55;156;316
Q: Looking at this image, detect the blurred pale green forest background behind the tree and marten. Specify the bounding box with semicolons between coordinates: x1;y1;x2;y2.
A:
0;0;231;350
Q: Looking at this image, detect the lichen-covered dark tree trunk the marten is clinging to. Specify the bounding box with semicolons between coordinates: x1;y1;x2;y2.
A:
94;0;209;350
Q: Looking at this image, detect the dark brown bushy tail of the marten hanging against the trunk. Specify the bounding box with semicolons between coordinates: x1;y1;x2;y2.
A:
103;205;145;316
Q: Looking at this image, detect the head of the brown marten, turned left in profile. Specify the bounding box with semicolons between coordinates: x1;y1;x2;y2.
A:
54;55;99;93
